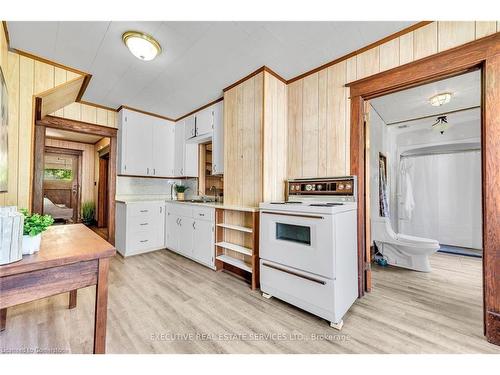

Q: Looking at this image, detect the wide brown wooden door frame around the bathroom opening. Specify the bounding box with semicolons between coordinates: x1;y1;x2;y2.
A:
346;33;500;345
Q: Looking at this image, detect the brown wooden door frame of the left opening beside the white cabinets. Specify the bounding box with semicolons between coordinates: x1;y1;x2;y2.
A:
31;113;118;245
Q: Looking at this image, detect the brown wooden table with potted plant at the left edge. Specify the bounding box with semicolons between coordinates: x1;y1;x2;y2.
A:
0;224;116;353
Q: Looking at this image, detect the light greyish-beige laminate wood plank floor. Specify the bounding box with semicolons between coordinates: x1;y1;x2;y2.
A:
0;250;500;353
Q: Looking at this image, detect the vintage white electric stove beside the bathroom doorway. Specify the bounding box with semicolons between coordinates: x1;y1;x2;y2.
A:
260;176;358;329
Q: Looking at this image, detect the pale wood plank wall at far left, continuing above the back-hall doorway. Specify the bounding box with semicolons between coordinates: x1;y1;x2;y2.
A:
0;33;116;208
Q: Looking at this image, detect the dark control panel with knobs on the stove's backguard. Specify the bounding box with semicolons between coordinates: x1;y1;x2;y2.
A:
286;176;356;196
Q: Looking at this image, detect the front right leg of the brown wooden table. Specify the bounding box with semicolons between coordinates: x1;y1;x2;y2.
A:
94;258;109;354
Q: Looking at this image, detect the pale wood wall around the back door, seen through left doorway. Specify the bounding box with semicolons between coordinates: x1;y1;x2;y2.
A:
45;139;96;203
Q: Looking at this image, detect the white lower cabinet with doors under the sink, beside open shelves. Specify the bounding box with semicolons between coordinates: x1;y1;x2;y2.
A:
165;203;215;269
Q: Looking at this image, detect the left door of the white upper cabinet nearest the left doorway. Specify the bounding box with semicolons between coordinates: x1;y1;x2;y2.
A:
121;110;153;176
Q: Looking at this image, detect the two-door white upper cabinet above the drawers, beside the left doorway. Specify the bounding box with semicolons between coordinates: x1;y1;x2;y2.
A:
118;109;174;177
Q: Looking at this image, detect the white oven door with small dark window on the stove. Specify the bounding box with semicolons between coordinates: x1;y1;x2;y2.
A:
259;210;334;278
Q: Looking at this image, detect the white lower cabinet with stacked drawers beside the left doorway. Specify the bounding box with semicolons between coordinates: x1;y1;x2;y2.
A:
115;201;165;256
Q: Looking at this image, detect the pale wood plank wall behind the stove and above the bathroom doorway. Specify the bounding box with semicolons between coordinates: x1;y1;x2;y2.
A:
287;21;500;178
